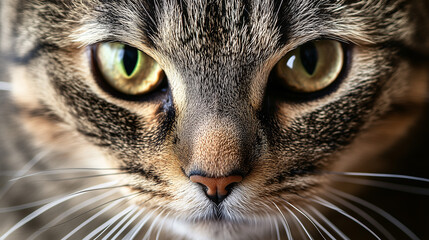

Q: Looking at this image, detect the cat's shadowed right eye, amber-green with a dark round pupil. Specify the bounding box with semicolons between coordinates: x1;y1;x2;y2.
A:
274;40;344;93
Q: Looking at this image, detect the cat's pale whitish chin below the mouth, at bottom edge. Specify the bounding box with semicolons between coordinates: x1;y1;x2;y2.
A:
165;219;276;240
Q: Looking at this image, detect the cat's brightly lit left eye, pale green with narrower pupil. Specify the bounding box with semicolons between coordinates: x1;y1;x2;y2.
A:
95;43;164;95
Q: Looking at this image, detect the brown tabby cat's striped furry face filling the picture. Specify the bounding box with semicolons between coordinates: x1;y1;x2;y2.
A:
3;0;428;239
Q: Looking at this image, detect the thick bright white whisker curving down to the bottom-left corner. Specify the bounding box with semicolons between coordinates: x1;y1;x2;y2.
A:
0;181;117;240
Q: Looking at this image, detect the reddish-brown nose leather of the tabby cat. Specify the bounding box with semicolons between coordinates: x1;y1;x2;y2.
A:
189;175;243;204
